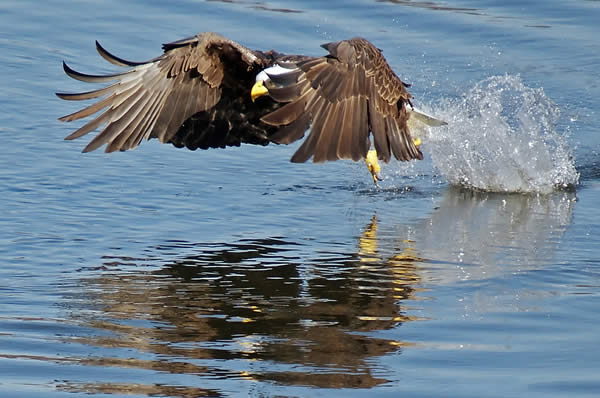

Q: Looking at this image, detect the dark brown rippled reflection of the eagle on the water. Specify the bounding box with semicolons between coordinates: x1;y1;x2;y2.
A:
65;230;418;396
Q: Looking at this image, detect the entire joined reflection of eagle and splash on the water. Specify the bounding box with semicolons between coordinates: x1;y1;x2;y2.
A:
42;188;575;397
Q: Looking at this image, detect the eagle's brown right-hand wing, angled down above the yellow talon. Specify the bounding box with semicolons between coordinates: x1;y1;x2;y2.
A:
261;38;423;162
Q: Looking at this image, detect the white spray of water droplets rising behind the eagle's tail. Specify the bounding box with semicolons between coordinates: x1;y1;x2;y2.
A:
426;75;579;193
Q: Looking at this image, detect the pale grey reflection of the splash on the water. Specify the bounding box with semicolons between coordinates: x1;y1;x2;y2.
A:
412;187;577;285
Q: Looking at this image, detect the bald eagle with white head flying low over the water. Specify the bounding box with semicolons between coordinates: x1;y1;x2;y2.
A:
56;32;444;182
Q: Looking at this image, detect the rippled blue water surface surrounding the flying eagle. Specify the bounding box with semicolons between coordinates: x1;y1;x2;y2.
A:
0;0;600;398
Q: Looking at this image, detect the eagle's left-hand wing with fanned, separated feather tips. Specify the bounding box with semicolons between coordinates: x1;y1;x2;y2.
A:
56;33;268;152
